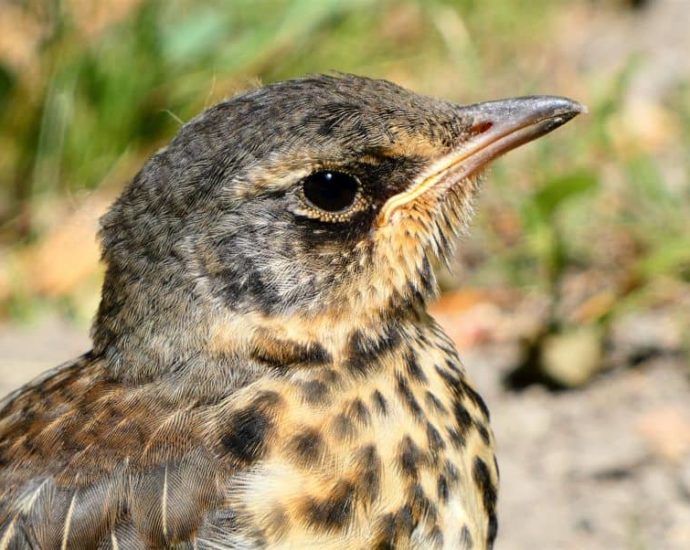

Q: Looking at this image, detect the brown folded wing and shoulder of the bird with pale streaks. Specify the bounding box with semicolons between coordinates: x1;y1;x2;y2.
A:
0;354;268;549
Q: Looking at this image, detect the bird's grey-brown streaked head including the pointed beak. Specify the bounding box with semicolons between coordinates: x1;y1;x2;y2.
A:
95;76;583;376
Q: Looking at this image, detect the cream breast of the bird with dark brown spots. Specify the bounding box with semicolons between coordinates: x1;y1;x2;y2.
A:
207;325;497;548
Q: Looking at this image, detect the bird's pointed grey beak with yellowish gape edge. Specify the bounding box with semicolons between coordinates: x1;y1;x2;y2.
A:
381;96;587;223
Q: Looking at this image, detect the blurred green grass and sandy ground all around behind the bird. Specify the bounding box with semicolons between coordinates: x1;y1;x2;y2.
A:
0;0;690;549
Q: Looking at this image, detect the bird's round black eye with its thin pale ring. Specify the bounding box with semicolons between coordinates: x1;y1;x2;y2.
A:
299;169;366;221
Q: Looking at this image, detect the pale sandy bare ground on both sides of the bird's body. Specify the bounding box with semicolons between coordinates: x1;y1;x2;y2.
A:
0;314;690;550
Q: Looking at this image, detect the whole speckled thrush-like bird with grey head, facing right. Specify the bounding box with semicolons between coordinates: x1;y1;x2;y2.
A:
0;73;584;550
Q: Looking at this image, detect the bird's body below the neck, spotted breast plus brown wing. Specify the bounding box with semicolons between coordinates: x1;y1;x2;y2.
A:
0;322;497;549
